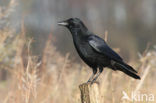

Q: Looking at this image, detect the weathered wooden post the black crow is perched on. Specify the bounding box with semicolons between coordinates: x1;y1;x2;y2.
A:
79;83;100;103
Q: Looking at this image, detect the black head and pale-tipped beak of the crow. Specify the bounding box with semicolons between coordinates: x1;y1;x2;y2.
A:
58;18;87;30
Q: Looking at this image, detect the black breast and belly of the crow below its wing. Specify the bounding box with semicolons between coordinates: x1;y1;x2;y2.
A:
74;37;109;67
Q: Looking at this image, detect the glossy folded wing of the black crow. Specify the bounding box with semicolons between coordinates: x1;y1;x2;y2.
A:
88;35;122;61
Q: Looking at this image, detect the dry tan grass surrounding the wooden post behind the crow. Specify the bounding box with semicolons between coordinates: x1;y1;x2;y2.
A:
0;0;156;103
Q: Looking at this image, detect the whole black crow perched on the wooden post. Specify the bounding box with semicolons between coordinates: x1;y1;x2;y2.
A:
58;18;140;83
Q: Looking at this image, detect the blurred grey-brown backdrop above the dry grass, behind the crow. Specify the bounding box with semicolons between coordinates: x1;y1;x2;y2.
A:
0;0;156;60
